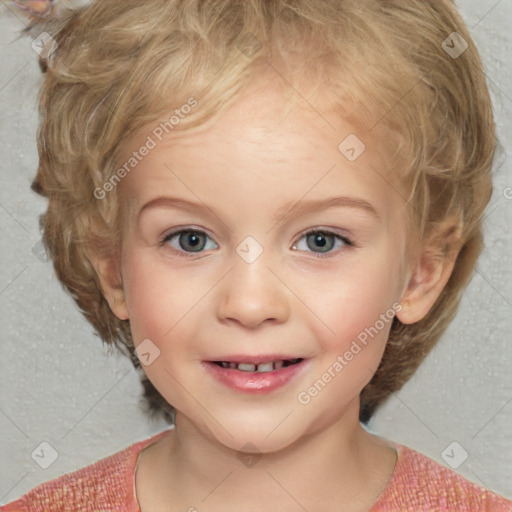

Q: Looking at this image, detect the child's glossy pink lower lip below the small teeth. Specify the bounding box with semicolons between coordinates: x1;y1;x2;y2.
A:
203;359;308;394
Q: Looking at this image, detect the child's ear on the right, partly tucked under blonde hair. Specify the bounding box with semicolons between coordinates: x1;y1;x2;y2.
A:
396;220;461;324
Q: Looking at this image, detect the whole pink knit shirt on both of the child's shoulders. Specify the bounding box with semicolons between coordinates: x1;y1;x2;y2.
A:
0;430;512;512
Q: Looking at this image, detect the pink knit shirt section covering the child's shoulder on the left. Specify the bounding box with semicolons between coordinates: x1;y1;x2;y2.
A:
0;431;172;512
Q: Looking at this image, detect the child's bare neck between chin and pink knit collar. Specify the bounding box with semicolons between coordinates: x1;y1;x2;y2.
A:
154;401;395;512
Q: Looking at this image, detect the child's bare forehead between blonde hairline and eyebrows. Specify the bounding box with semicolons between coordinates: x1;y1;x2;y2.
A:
116;74;405;224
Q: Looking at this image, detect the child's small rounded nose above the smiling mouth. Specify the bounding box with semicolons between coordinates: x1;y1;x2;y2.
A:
217;251;291;329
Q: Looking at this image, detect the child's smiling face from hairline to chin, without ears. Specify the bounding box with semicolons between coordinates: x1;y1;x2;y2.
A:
116;78;412;452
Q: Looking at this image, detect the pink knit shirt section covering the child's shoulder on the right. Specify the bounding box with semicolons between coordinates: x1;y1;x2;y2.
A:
372;444;512;512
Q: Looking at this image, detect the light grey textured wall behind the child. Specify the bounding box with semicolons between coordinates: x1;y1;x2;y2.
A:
0;0;512;503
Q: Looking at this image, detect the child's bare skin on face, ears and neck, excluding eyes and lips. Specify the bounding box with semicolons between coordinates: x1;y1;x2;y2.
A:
95;73;458;512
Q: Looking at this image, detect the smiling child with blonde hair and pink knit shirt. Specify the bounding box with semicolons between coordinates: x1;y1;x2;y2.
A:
2;0;512;512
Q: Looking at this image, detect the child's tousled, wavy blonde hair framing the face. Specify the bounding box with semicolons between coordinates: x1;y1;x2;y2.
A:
32;0;496;422
